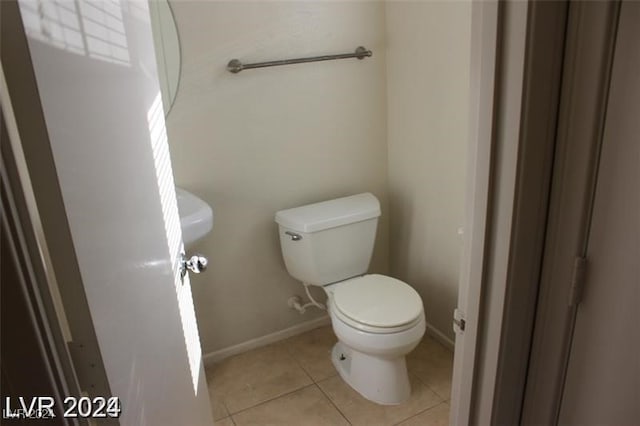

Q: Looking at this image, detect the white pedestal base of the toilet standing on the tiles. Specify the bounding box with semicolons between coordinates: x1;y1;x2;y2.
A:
331;342;411;405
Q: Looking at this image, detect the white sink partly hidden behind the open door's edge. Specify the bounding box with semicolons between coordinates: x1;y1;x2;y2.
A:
176;187;213;246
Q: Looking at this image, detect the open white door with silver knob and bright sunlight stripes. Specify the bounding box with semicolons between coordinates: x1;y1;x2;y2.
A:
14;0;212;426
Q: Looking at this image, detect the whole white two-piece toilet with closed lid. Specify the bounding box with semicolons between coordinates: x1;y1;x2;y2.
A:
276;193;425;405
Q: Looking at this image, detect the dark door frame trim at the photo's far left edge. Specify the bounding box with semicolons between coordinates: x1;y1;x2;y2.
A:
0;95;80;424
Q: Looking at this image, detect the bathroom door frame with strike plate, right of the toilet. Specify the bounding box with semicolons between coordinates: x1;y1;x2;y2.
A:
450;1;568;425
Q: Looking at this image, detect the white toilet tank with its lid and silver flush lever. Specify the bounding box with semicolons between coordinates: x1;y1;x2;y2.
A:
276;193;380;286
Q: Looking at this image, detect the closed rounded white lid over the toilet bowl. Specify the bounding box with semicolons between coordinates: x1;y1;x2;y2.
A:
333;274;422;328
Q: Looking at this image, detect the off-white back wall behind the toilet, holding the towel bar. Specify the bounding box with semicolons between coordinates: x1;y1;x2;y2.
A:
167;2;389;353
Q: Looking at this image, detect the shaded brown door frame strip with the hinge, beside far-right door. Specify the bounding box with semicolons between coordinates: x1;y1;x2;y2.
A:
521;1;621;424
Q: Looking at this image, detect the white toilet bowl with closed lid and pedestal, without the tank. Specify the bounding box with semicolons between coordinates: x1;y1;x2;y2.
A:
325;275;426;405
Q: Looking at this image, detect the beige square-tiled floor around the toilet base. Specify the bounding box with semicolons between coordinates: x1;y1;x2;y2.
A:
206;326;453;426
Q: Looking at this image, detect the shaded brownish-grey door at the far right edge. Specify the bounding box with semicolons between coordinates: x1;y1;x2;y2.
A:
558;1;640;425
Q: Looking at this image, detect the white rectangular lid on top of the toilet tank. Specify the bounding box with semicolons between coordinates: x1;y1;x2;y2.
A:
276;192;380;233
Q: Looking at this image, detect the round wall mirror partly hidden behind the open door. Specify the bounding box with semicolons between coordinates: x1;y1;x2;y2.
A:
149;0;181;116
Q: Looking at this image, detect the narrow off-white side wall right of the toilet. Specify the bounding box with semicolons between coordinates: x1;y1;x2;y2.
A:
386;1;471;339
